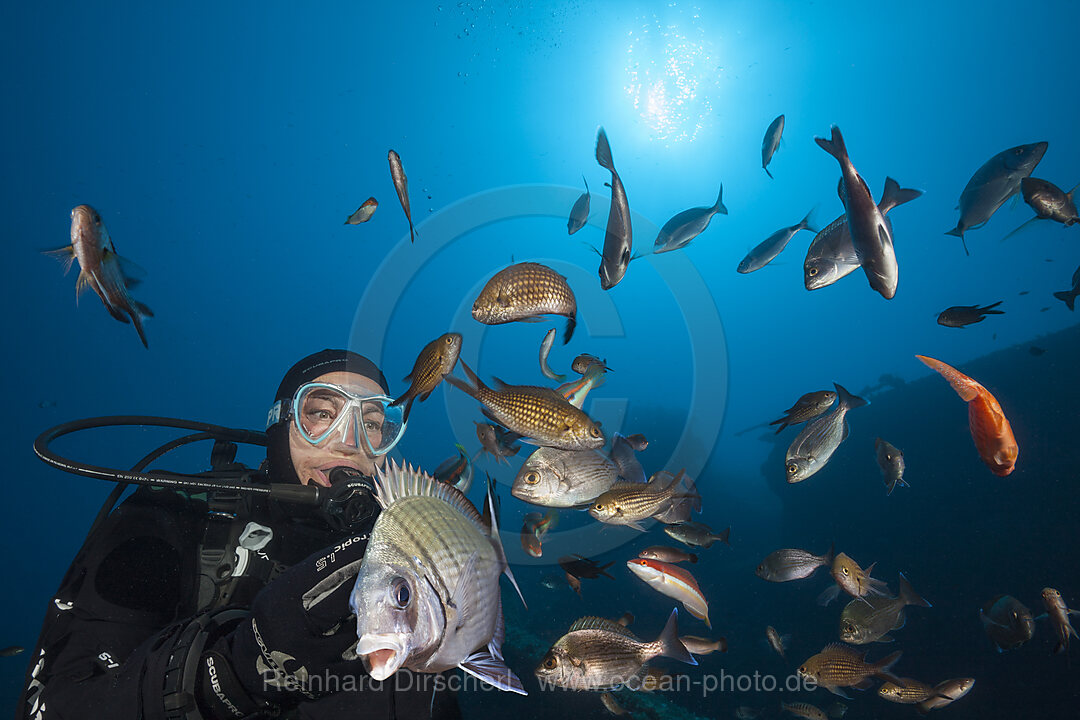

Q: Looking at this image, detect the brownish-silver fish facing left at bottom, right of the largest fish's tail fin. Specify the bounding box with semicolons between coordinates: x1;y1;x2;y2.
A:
536;610;698;690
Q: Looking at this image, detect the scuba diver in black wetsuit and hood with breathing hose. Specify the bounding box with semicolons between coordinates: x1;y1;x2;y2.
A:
16;350;460;720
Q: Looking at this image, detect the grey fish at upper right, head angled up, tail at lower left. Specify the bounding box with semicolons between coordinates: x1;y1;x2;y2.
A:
945;142;1049;255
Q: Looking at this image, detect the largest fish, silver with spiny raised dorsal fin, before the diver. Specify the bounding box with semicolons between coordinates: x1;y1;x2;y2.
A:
350;462;526;695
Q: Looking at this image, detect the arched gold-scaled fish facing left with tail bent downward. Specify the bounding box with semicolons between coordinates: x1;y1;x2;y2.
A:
472;262;578;344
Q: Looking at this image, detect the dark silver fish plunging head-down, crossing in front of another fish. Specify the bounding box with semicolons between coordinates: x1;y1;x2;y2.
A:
814;125;900;300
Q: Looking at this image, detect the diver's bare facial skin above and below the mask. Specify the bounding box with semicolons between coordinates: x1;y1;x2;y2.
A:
288;371;384;488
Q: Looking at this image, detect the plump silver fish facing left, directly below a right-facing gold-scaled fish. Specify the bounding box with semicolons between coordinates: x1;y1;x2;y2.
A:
510;448;618;507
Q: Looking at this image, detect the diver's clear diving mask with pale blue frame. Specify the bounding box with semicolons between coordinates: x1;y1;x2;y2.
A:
268;382;405;457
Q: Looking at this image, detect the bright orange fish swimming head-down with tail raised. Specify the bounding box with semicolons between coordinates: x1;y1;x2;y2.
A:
916;355;1020;477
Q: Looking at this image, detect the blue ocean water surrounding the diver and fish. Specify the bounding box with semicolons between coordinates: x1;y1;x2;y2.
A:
0;0;1080;718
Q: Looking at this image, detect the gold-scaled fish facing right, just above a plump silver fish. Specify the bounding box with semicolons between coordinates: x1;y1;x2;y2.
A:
446;361;604;450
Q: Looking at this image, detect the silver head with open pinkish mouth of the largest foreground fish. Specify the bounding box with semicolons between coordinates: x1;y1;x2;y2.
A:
349;552;446;681
